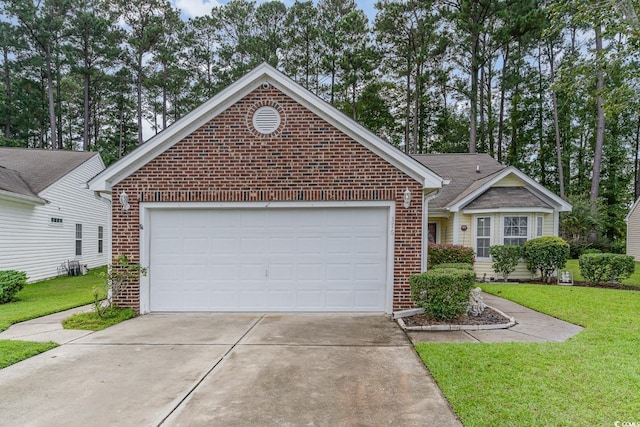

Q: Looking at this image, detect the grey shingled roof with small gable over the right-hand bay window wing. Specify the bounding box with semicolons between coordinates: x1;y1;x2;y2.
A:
414;153;571;212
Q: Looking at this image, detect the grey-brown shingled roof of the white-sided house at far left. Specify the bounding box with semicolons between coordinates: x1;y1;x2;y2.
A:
0;147;99;203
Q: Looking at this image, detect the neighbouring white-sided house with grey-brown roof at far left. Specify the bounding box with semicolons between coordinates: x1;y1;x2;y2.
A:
0;148;111;282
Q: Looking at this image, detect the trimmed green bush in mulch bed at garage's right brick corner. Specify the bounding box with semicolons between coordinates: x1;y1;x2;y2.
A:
409;268;476;320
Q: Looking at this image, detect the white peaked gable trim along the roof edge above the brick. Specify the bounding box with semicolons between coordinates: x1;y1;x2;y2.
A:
89;63;443;191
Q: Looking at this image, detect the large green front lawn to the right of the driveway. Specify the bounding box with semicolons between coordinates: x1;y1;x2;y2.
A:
416;284;640;426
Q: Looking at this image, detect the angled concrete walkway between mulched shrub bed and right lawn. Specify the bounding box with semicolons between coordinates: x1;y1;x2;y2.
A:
407;292;584;344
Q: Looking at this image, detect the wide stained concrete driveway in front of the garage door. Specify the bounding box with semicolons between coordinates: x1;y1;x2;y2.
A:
0;314;460;426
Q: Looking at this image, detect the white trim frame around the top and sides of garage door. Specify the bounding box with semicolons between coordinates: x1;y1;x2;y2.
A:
140;201;395;314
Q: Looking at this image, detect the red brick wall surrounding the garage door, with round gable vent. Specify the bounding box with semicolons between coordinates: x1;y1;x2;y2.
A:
113;88;422;311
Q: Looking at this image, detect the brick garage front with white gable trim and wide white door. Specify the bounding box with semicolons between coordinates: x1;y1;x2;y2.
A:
89;64;443;313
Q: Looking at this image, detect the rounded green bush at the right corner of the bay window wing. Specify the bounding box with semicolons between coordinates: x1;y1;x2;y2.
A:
522;236;569;283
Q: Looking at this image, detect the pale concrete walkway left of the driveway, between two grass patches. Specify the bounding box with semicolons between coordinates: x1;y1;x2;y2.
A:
0;305;93;344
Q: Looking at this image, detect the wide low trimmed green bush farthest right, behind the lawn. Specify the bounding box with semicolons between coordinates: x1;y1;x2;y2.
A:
578;253;636;284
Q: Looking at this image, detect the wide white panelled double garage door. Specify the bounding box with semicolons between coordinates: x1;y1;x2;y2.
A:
149;207;389;312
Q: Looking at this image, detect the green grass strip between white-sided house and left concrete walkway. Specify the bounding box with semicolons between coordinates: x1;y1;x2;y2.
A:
0;267;106;332
